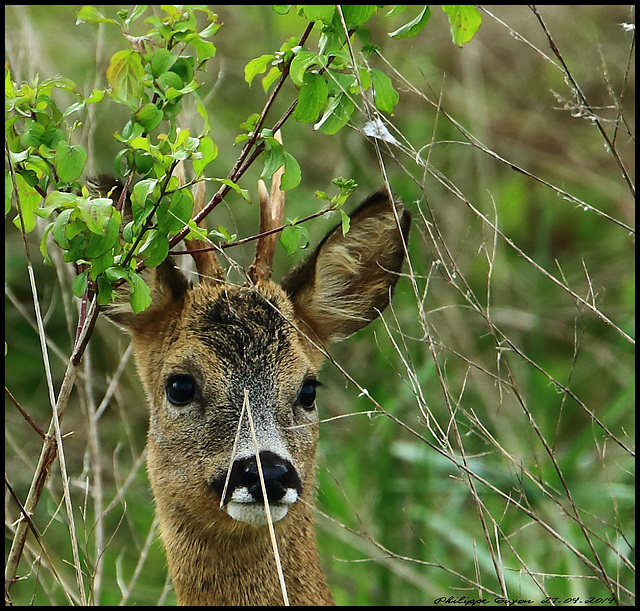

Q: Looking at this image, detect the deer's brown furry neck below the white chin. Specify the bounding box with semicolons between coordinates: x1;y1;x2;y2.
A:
158;504;335;606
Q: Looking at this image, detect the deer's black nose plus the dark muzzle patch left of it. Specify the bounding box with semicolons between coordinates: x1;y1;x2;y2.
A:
212;451;302;503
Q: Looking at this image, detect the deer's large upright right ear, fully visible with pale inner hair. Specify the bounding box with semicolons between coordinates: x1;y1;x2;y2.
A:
282;190;411;342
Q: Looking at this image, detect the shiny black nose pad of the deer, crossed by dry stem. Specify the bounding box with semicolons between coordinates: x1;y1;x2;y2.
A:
240;451;302;503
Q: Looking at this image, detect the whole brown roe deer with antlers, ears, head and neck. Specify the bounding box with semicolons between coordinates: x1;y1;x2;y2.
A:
109;173;410;605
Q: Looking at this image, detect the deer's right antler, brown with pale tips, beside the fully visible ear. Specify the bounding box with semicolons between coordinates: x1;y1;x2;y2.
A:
248;130;284;284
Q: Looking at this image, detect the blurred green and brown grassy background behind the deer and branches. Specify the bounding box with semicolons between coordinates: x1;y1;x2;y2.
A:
5;6;635;605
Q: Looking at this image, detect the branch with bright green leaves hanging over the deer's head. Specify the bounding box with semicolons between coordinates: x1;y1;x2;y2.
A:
5;5;479;599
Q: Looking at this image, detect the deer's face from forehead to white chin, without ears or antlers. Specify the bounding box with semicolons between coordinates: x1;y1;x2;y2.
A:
133;278;318;526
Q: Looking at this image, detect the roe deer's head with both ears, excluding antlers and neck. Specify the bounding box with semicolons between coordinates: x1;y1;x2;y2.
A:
111;193;409;530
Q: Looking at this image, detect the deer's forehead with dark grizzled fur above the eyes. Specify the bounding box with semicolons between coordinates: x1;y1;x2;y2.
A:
137;282;311;388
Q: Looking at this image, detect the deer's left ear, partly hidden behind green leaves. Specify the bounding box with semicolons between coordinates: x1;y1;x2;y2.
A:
105;257;189;334
